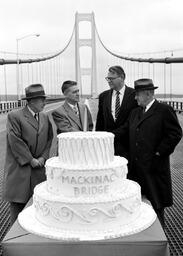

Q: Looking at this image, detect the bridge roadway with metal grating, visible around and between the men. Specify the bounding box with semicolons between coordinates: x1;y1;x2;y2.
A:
0;102;183;256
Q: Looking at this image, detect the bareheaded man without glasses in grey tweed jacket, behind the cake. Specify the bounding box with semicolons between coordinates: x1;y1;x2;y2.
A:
52;80;93;134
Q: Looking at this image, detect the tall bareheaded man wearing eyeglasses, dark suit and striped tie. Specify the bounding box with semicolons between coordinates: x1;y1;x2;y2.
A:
96;66;138;158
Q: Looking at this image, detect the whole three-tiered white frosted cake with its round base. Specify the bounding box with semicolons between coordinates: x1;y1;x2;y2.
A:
18;132;156;240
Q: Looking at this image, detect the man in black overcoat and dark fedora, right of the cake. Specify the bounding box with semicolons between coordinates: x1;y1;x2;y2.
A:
113;78;182;227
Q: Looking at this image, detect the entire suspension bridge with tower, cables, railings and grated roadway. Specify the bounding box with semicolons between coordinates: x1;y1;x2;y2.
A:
0;13;183;255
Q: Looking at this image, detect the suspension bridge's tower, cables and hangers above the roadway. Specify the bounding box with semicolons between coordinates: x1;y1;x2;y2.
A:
0;13;183;102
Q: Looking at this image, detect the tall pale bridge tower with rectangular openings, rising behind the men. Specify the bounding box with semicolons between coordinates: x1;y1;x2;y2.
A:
75;12;97;97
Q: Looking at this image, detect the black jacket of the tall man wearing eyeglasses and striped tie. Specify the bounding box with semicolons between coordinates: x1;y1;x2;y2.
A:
96;86;138;158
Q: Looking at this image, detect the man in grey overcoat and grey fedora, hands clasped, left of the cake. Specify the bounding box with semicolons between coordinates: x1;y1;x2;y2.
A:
4;84;53;224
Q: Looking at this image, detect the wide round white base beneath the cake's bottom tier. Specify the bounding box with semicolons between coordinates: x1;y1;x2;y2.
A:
18;202;156;241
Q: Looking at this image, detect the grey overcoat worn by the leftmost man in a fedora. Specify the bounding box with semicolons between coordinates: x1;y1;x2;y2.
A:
4;107;53;203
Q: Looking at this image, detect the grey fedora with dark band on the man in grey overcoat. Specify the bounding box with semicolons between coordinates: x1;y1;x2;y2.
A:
22;84;47;100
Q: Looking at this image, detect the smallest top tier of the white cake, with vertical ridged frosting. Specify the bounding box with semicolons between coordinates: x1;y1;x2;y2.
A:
58;132;114;167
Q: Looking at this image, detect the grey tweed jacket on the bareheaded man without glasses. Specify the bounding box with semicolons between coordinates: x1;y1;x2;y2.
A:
52;101;93;134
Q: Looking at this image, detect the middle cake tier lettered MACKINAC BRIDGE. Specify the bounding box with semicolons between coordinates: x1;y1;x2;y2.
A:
46;156;128;197
